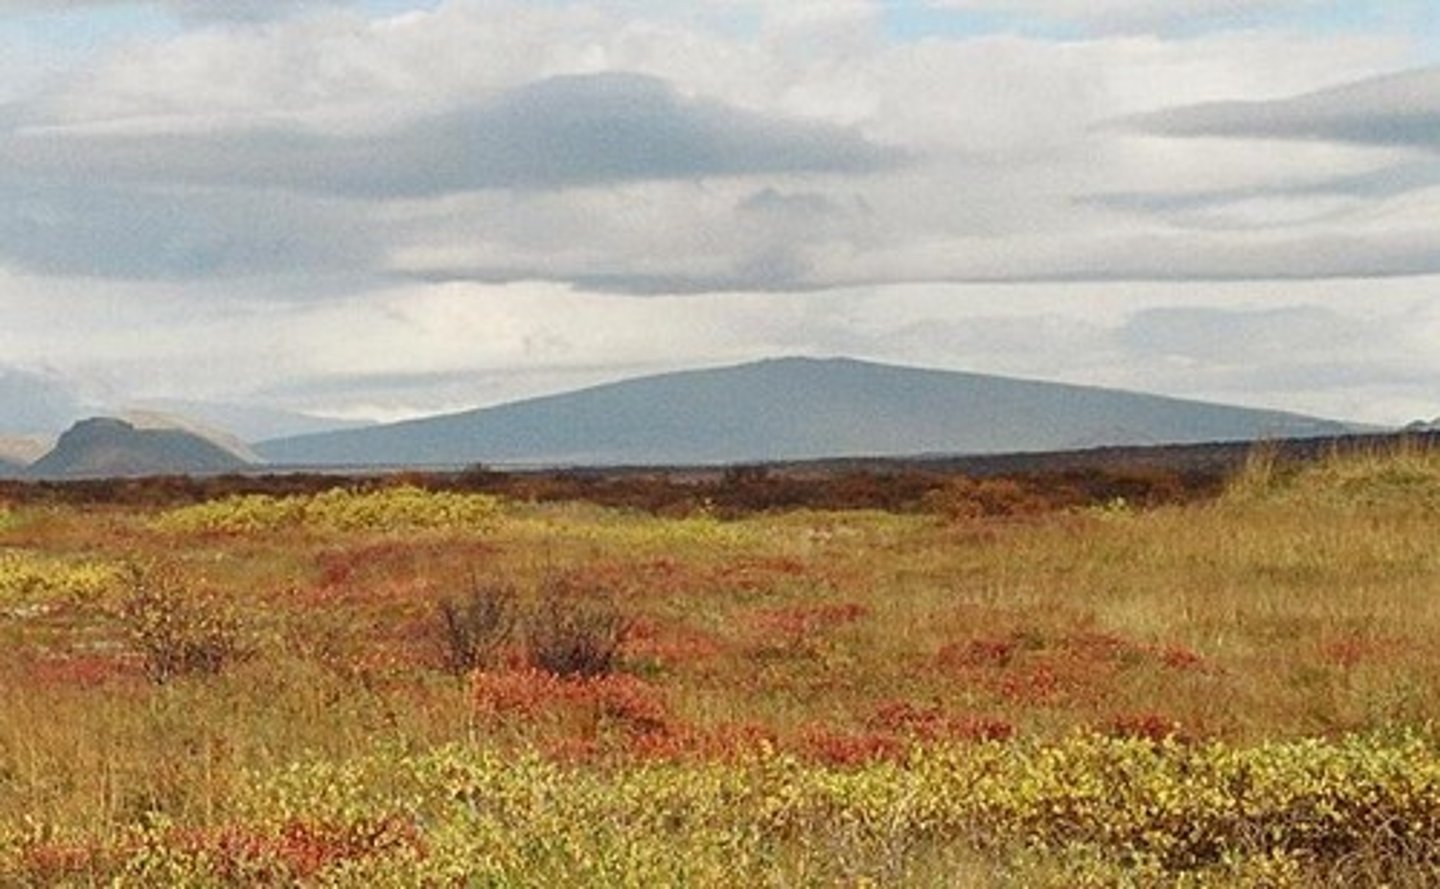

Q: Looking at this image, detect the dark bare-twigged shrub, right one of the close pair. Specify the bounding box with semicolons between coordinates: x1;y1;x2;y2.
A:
526;578;629;676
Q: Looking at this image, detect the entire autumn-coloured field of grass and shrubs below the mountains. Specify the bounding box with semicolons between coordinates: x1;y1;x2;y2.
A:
0;447;1440;886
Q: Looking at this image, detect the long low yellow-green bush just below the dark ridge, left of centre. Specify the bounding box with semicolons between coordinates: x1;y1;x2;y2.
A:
154;486;501;533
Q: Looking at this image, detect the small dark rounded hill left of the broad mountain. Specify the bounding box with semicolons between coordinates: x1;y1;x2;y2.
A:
24;416;256;478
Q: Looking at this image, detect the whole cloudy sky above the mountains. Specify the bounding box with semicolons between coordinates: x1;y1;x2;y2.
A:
0;0;1440;435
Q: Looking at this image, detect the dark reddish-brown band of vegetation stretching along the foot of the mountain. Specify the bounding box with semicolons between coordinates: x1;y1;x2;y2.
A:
0;432;1440;517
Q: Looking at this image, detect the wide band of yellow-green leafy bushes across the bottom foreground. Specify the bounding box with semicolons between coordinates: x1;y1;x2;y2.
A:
11;735;1440;886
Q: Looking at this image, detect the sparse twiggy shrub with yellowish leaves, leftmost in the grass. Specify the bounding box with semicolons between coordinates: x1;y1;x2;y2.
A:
117;563;253;684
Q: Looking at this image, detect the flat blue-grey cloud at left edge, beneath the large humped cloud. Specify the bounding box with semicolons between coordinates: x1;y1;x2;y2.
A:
0;183;382;280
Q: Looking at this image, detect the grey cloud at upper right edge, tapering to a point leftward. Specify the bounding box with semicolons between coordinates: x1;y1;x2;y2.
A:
1122;68;1440;151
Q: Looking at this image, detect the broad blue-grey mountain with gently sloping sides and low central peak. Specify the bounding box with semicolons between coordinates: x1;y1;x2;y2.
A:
256;359;1349;465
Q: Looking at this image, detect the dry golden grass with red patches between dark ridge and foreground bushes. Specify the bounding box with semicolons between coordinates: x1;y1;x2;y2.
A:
0;450;1440;883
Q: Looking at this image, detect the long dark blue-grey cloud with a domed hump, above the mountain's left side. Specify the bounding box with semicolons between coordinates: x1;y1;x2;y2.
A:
0;73;900;197
